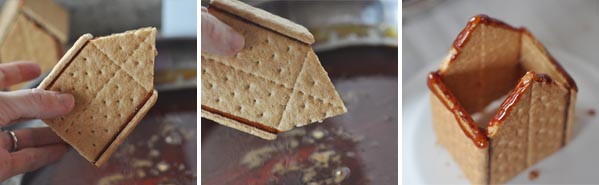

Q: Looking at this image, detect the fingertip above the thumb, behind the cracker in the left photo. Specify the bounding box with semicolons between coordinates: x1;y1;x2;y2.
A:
0;62;42;88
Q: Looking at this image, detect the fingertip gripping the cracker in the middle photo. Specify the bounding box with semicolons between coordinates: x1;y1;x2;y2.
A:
201;7;245;55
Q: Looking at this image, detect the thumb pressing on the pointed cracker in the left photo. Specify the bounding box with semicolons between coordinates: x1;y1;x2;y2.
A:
0;89;75;126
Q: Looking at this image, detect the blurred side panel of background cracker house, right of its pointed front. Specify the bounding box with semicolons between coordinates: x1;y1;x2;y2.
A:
21;0;69;44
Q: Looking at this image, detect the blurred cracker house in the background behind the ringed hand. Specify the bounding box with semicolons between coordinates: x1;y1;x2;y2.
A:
0;0;68;90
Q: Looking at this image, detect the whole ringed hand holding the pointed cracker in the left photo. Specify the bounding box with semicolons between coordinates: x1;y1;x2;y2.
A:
0;62;75;182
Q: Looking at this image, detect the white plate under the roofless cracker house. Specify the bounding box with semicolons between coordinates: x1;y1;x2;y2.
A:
402;49;599;184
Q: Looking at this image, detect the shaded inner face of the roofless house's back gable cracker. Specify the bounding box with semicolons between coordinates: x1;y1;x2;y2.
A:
440;19;524;112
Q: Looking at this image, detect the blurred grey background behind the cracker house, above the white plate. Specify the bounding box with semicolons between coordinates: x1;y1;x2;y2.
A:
402;0;599;83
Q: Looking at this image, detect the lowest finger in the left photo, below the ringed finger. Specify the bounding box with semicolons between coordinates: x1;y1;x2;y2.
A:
6;144;67;177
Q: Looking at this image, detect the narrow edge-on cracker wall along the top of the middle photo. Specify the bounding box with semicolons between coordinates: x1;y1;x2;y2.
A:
210;0;314;44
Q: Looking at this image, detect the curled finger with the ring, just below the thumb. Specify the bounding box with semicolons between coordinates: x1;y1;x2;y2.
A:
14;127;63;149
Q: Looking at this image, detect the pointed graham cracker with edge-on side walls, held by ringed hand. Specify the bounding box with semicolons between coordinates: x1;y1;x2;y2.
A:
38;28;158;166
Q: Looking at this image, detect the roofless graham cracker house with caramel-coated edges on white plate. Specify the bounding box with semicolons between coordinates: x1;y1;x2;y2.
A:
427;15;578;184
